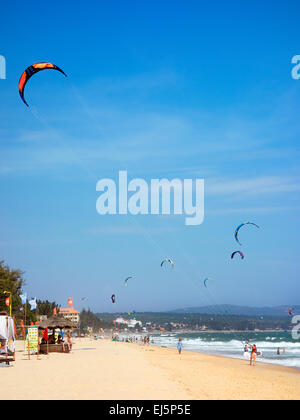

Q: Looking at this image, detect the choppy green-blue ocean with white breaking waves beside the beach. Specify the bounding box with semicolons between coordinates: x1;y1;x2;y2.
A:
151;331;300;369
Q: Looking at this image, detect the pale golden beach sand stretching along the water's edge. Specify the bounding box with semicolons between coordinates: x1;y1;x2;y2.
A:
0;338;300;400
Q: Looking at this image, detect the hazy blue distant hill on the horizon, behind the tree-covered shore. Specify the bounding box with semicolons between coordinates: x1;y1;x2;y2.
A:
169;305;300;316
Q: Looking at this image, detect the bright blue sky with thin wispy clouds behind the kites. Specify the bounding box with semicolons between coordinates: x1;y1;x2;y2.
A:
0;1;300;311
